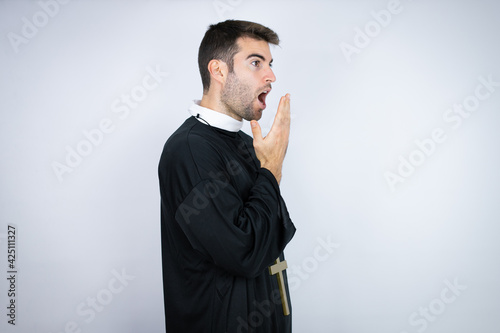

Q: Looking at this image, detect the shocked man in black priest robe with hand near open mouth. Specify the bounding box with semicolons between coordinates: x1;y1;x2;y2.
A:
159;20;295;333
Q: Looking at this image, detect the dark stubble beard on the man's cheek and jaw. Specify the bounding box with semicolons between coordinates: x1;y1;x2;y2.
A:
221;72;262;121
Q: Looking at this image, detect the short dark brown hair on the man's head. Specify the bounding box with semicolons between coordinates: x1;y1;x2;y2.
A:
198;20;280;93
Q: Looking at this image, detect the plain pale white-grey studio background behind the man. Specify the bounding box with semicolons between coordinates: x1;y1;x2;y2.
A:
0;0;500;333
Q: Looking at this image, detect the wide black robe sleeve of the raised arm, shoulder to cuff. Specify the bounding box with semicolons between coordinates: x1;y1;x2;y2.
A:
160;120;295;277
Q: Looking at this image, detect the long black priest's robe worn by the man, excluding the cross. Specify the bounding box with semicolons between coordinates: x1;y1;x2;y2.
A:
158;117;295;333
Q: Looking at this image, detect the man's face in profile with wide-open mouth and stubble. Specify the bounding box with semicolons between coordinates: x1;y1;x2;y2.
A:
221;37;276;121
